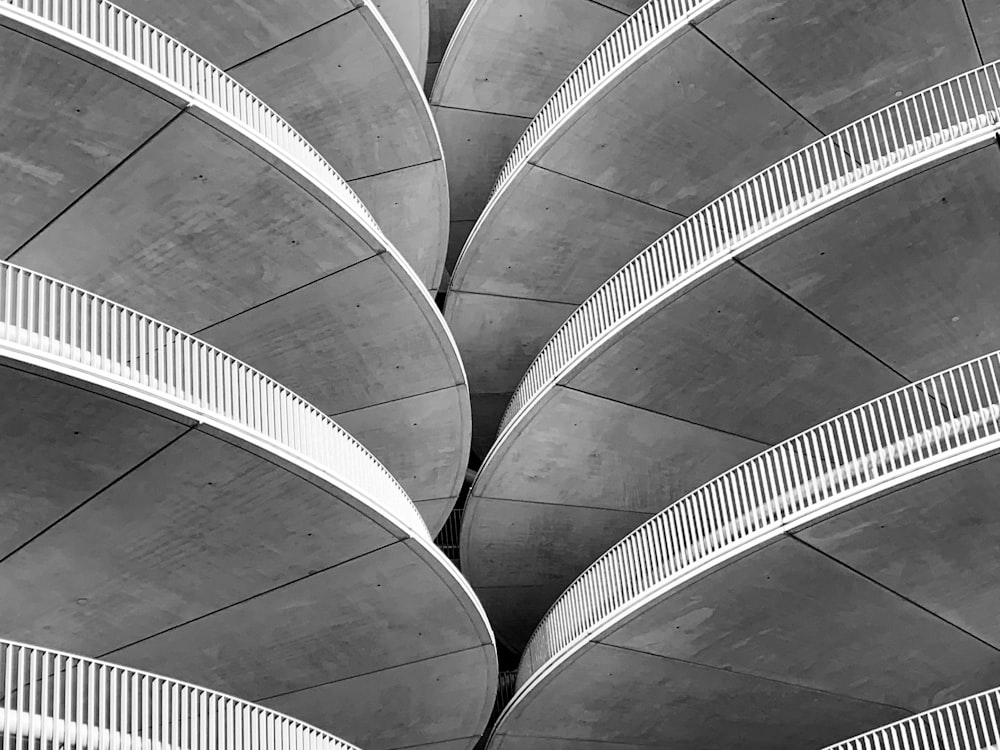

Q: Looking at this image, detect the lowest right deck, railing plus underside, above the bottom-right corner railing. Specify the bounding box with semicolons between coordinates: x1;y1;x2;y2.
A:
489;353;1000;750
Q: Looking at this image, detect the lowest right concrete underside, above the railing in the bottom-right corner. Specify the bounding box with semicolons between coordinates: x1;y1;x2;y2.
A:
491;453;1000;749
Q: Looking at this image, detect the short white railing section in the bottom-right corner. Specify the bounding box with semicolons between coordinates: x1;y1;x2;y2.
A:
827;688;1000;750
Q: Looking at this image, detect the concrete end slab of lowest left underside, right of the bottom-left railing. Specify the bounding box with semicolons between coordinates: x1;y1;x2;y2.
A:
261;649;493;750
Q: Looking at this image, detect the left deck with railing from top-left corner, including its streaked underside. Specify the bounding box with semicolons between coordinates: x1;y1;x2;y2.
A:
0;0;471;531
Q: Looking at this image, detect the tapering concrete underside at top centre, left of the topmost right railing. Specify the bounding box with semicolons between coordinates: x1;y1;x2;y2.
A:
431;0;645;276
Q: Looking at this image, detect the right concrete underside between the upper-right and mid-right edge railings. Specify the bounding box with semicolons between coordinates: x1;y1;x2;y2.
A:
460;134;1000;648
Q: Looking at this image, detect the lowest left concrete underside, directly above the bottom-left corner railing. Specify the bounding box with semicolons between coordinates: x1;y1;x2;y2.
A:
0;359;496;749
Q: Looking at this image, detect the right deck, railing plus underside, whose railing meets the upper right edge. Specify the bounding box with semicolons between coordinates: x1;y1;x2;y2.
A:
461;63;1000;649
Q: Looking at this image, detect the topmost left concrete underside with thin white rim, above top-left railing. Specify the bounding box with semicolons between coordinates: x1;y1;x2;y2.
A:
120;0;448;291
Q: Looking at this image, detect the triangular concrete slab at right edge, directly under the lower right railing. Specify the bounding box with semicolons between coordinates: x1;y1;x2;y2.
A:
796;455;1000;646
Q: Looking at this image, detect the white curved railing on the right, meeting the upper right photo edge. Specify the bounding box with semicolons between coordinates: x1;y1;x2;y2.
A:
500;62;1000;432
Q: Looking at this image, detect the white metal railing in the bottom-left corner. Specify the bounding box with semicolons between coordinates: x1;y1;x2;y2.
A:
0;640;355;750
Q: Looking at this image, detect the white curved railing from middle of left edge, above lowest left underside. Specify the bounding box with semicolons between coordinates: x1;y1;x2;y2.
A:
0;263;430;543
